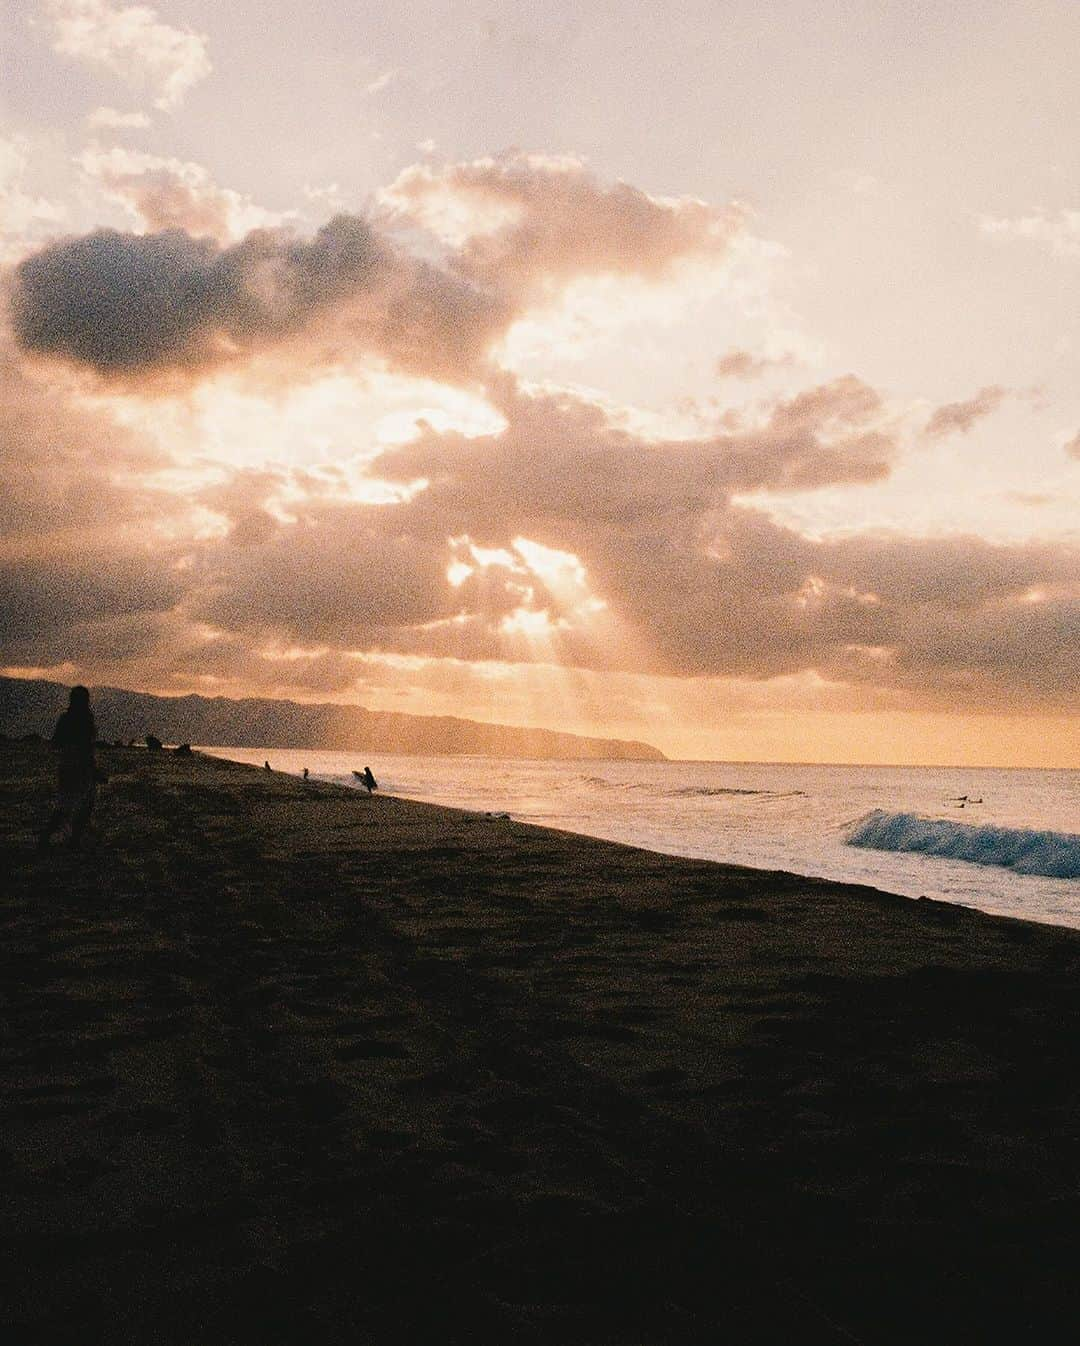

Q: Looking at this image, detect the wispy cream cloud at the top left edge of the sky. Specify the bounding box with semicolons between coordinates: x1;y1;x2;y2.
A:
46;0;213;110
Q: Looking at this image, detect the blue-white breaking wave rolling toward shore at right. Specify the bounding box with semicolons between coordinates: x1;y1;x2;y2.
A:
844;809;1080;879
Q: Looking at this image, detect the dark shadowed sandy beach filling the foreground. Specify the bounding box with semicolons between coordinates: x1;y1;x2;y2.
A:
0;748;1080;1346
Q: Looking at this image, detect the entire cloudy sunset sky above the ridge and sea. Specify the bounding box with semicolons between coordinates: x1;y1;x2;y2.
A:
0;0;1080;767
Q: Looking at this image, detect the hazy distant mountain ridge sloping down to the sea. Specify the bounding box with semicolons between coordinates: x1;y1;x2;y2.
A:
0;677;665;762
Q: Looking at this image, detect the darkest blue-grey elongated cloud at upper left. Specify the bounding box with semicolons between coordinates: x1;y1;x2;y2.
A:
12;209;502;380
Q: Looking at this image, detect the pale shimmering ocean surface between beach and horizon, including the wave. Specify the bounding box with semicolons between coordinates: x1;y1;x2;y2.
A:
203;747;1080;927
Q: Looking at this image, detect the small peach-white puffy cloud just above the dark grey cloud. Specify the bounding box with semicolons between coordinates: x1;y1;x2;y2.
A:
78;145;285;244
